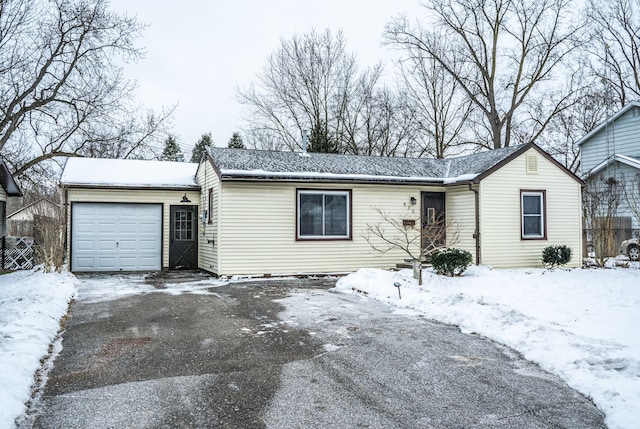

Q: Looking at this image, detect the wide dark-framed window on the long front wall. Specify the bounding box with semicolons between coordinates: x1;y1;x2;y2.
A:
296;189;351;240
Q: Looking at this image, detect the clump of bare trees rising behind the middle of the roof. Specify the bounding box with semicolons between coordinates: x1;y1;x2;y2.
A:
238;31;415;156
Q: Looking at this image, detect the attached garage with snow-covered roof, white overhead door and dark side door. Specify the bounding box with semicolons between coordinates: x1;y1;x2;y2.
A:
60;158;201;272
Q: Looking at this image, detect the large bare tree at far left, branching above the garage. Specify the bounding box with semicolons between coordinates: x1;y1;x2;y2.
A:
0;0;171;182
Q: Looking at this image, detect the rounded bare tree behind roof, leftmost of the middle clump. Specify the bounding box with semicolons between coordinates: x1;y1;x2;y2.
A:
238;30;357;150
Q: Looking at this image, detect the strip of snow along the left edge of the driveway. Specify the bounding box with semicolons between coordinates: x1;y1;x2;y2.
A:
0;271;78;428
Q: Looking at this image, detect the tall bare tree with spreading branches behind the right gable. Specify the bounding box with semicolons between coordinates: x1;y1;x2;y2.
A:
386;0;583;149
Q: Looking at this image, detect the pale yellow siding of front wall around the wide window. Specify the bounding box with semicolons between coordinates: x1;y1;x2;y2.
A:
219;182;442;275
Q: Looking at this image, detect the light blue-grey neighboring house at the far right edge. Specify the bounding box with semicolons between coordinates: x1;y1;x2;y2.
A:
576;102;640;231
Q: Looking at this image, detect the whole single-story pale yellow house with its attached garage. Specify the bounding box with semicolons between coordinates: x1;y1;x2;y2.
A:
61;144;582;275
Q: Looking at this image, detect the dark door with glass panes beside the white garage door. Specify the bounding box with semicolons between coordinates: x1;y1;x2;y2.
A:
169;206;198;270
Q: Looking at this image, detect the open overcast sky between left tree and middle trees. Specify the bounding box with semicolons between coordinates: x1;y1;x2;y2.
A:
111;0;424;154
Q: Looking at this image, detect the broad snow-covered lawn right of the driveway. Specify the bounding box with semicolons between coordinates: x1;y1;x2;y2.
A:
336;267;640;429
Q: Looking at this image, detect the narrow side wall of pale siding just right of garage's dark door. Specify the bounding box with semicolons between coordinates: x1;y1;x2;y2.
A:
196;156;220;274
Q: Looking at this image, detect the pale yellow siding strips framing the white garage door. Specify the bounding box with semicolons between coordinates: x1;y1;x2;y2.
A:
67;188;200;268
